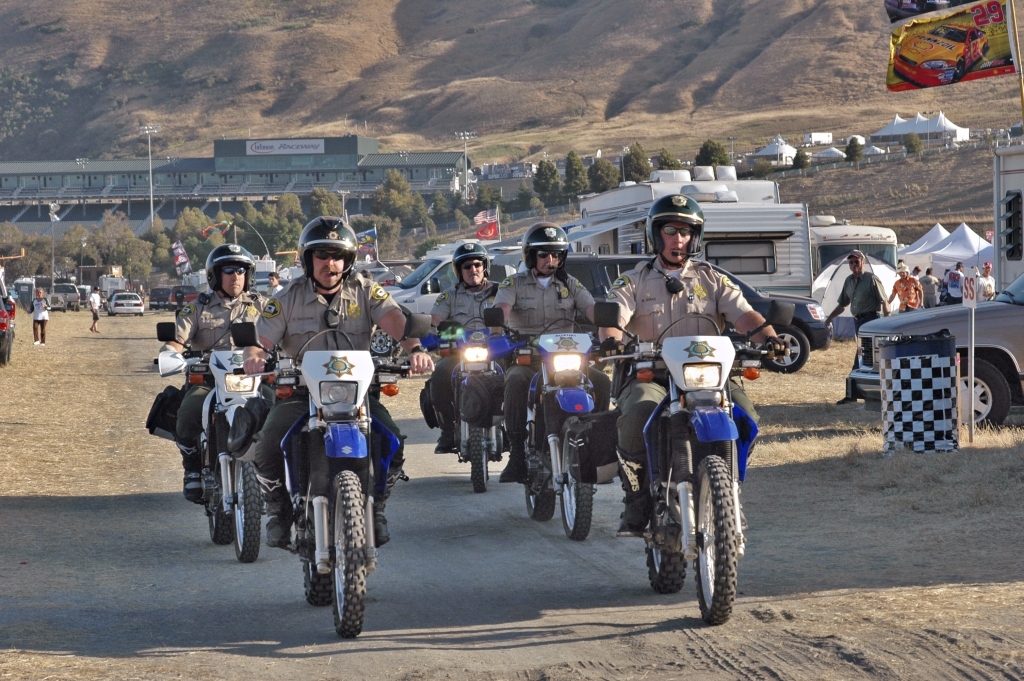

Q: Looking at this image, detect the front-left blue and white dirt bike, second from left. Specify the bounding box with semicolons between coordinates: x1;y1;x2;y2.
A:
231;314;430;638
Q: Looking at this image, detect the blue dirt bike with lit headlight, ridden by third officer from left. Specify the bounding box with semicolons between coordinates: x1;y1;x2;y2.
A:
432;320;525;493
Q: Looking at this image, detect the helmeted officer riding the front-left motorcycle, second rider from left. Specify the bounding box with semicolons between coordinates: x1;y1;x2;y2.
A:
245;216;433;548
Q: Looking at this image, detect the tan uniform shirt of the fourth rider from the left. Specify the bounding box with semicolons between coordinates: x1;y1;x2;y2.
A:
495;269;594;336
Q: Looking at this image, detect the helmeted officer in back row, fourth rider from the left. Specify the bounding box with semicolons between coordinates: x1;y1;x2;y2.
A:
495;222;611;482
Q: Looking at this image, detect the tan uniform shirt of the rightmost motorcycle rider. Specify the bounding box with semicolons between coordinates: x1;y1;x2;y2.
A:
608;259;754;342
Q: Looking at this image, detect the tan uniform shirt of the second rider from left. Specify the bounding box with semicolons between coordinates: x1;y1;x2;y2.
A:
257;272;399;359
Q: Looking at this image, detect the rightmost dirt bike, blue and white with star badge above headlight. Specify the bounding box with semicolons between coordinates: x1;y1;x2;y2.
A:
594;301;794;625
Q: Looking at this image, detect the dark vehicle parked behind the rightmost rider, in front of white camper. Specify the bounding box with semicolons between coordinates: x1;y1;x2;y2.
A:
565;253;831;374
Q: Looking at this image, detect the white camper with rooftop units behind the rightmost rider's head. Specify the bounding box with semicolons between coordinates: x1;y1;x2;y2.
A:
565;166;812;296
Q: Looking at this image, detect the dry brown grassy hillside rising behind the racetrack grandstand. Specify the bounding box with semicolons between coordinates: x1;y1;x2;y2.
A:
0;0;1020;161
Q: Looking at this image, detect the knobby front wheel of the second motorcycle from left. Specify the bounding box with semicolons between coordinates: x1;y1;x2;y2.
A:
330;471;367;638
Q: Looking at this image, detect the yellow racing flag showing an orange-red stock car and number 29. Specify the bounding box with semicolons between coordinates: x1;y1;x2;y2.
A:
886;0;1015;92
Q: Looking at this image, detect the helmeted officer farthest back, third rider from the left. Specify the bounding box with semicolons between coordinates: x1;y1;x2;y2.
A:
429;244;498;454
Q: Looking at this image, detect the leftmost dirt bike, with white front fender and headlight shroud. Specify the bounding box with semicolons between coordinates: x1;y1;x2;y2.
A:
157;322;263;563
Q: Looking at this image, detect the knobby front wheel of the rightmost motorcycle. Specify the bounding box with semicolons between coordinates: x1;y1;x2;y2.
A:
693;456;739;625
